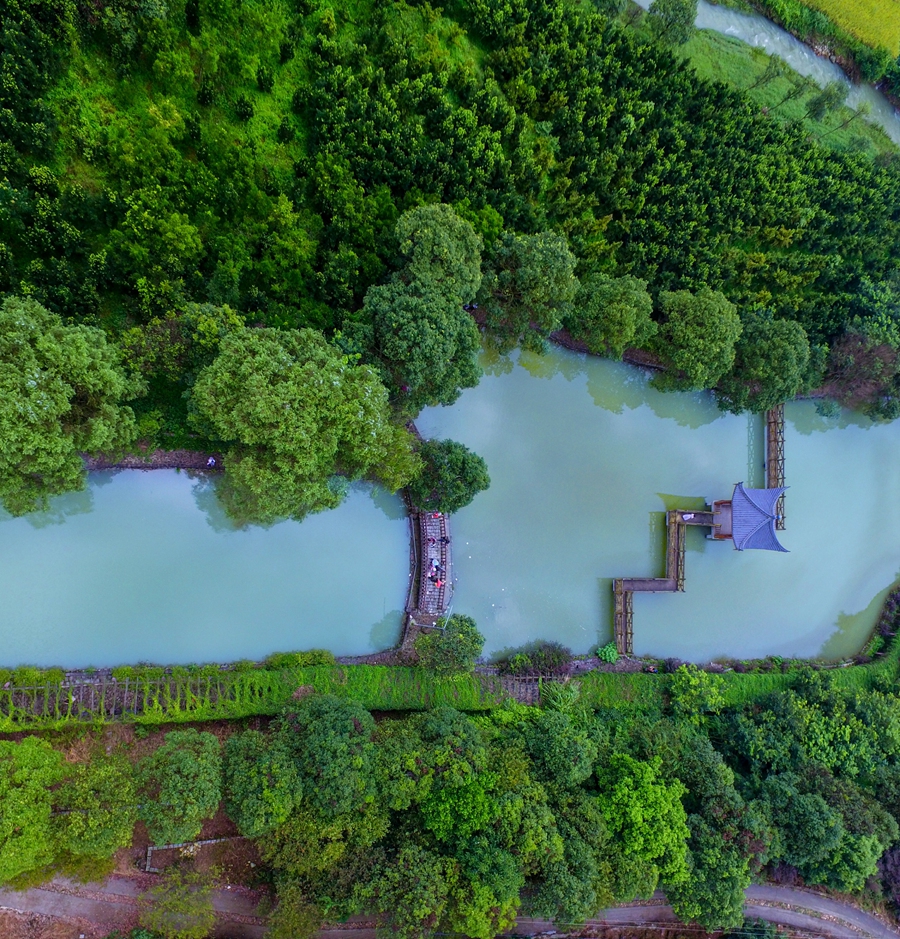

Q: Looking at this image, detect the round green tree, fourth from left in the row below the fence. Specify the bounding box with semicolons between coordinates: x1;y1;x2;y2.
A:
224;730;303;838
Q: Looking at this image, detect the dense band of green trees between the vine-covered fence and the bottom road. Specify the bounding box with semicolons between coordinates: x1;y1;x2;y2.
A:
0;663;900;937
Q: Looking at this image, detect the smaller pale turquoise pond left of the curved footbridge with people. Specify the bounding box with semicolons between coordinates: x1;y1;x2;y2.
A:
0;478;409;667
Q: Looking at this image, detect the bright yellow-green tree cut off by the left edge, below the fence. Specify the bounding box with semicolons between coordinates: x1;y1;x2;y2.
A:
0;737;64;883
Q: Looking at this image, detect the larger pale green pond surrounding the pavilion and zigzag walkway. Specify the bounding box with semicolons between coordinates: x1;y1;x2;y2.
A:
417;350;900;660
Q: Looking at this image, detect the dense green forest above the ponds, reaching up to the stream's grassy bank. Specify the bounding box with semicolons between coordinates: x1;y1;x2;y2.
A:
0;0;900;520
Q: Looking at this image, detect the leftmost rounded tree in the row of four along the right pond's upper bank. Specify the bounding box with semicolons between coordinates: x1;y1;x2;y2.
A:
478;232;578;351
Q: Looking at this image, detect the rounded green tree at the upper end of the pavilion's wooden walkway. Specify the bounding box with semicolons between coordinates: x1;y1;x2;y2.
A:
716;312;810;413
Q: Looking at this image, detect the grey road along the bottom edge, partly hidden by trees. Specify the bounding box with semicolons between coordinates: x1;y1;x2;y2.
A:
0;877;900;939
